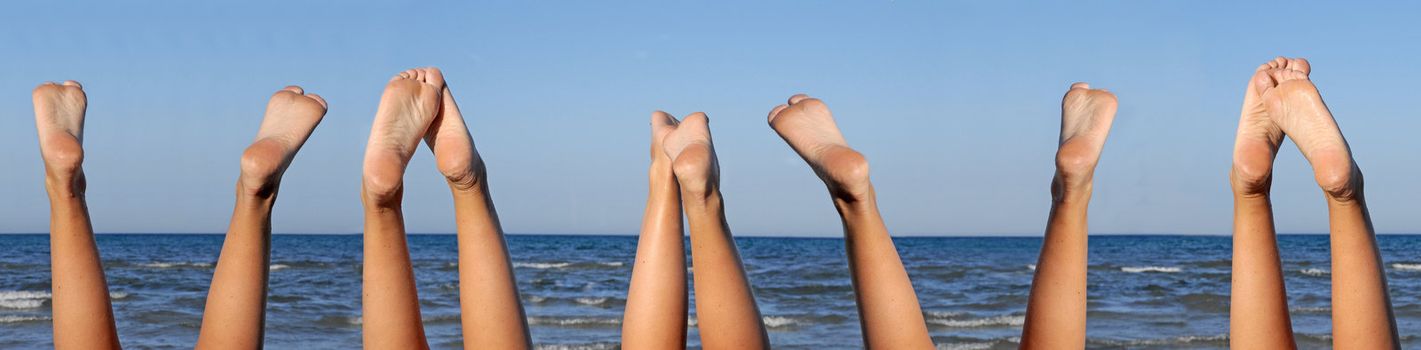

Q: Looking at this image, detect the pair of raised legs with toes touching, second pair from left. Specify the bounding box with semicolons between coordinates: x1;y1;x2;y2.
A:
361;68;531;349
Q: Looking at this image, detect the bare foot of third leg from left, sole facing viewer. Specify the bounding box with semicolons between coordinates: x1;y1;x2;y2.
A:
364;68;445;205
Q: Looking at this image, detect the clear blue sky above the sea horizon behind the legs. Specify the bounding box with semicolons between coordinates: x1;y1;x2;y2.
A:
0;1;1421;236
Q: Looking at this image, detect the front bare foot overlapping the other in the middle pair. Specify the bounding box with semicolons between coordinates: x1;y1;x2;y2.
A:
662;112;720;195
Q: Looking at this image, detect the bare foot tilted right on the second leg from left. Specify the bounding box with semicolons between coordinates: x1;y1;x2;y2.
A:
242;85;325;195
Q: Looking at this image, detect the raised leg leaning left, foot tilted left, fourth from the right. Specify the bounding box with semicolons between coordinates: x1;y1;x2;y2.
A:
769;95;934;349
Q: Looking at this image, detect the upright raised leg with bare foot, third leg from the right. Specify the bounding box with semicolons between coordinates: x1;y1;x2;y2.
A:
1022;83;1117;349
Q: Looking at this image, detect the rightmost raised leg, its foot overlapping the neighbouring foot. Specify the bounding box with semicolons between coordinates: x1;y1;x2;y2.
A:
1253;58;1401;349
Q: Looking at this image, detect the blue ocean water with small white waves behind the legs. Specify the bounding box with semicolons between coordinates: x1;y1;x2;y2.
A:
0;235;1421;349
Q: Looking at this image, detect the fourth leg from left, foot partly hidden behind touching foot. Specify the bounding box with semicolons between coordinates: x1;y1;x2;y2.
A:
425;81;533;349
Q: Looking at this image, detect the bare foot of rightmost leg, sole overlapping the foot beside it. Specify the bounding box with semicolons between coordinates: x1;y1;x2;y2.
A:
1253;58;1361;201
